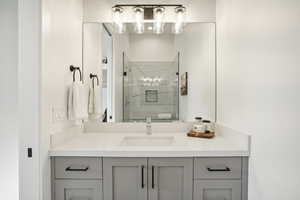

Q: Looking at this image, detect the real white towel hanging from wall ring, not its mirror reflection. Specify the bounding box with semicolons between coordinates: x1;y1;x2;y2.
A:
68;82;88;125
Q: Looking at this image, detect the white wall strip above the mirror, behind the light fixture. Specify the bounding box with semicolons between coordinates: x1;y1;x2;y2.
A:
84;0;216;22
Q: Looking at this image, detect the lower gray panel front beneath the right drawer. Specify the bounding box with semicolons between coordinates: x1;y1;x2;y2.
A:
194;180;242;200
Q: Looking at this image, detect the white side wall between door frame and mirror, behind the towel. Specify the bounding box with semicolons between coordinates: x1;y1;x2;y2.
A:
40;0;86;200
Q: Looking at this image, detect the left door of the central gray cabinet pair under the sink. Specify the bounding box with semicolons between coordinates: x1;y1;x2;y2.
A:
103;158;147;200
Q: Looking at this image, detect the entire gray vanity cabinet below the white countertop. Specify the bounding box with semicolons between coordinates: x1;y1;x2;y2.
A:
52;157;248;200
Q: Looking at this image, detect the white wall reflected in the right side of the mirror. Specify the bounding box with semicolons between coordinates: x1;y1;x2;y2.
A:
176;23;215;121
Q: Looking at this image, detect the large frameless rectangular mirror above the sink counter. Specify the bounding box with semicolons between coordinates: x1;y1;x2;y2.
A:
83;23;215;122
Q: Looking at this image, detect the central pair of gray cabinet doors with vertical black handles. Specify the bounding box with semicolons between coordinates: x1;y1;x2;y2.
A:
103;158;193;200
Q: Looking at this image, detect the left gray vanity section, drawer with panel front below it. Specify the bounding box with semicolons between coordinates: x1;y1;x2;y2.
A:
52;157;103;200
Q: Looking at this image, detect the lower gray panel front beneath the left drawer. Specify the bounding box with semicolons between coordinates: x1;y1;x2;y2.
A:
55;180;103;200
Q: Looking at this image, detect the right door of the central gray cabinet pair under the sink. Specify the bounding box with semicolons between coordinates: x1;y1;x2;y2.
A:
148;158;193;200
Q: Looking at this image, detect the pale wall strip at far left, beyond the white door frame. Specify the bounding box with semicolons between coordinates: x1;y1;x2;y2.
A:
0;0;19;200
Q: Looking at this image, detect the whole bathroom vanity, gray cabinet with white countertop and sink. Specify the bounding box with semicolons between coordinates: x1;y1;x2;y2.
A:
50;124;249;200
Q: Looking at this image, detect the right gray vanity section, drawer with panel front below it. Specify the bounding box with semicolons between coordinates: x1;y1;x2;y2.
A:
194;157;248;200
